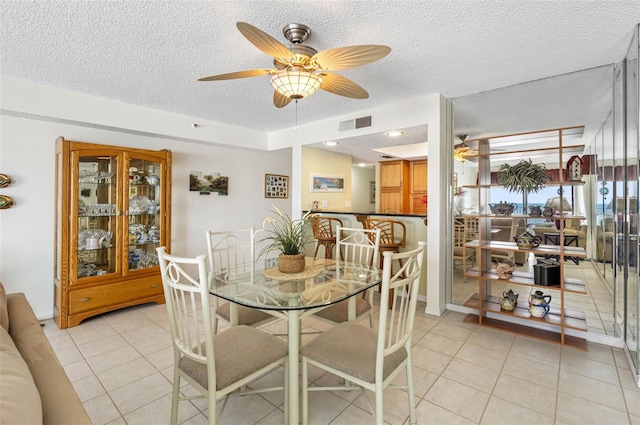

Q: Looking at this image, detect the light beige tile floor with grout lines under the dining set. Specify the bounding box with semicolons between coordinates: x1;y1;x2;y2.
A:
44;296;640;425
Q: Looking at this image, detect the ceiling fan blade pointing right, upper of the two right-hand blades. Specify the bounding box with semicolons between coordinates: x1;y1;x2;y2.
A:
311;44;391;71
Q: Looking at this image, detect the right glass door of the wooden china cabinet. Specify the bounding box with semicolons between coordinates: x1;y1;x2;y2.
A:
126;156;164;271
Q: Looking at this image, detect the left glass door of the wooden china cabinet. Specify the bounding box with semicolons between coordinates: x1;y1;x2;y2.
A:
72;155;119;279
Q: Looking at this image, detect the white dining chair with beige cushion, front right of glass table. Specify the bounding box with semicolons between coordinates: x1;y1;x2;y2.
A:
300;241;426;425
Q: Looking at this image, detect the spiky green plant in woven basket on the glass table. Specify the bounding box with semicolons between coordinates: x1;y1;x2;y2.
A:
260;206;313;273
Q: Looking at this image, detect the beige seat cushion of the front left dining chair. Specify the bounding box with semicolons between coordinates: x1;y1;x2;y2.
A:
178;325;289;391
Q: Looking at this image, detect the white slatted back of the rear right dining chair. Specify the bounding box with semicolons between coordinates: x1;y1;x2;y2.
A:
336;226;380;266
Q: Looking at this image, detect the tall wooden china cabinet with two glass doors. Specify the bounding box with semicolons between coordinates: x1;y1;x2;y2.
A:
54;137;171;328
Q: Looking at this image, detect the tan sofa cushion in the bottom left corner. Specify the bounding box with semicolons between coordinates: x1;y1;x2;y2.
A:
0;328;42;424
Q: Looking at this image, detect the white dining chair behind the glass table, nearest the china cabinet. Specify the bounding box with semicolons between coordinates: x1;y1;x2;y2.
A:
206;227;277;332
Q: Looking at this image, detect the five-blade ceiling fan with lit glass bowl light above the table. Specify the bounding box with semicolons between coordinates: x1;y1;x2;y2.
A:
198;22;391;108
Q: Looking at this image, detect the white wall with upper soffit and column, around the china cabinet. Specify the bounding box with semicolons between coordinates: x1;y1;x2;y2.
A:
0;77;450;318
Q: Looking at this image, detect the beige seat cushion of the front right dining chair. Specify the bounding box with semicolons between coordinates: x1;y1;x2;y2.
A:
300;322;407;383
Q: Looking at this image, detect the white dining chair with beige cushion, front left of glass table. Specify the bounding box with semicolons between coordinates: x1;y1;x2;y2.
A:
157;247;288;425
